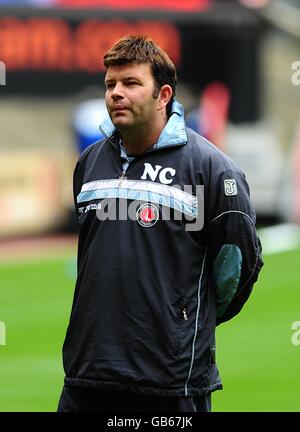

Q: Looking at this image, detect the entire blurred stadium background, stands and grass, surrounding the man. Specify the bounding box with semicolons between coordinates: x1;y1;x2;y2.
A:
0;0;300;411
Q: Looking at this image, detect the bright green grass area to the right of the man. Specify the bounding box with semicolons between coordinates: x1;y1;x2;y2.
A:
213;249;300;412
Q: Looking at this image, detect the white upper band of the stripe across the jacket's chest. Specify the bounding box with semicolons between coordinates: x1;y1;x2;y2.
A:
80;179;198;208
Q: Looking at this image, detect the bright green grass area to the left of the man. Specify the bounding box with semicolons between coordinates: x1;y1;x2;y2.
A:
0;258;75;412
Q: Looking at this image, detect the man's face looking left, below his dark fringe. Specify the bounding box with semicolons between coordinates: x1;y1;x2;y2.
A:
105;63;159;132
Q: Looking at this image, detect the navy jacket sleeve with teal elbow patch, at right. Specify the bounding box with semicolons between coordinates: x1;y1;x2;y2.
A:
206;169;263;325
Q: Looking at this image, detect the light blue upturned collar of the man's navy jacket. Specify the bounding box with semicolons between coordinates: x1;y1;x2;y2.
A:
100;100;187;150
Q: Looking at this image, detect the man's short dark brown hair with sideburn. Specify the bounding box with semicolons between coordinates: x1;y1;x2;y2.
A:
103;35;177;114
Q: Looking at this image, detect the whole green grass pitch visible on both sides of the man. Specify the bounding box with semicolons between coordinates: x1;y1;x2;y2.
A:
0;249;300;412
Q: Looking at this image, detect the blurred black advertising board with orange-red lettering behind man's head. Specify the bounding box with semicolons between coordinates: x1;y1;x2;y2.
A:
0;4;259;122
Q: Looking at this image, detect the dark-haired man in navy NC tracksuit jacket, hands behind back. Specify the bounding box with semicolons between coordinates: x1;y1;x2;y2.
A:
58;36;262;412
